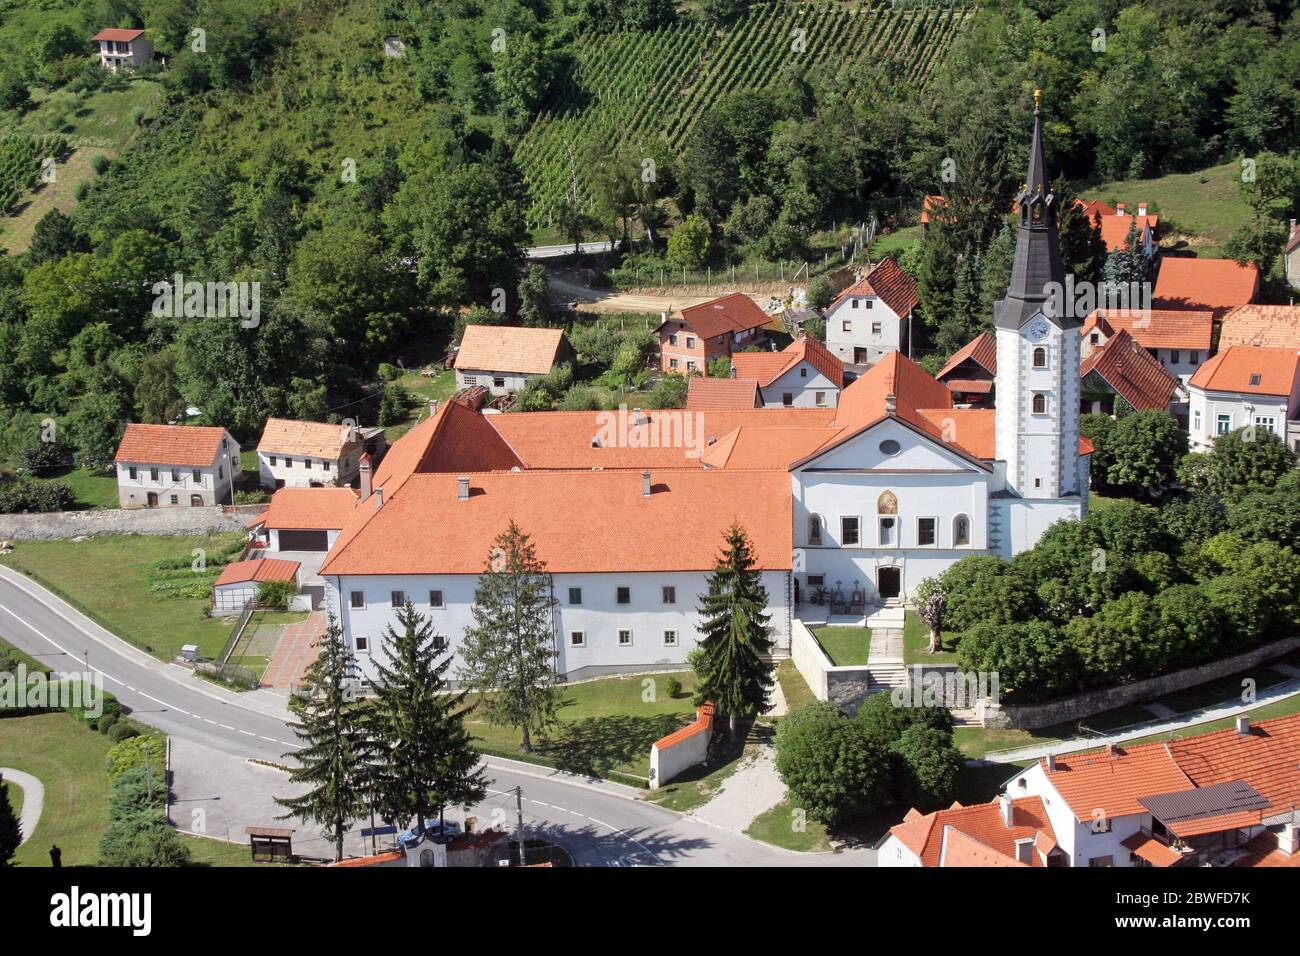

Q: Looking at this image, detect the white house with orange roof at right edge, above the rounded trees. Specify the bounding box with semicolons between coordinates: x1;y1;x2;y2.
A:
1187;345;1300;451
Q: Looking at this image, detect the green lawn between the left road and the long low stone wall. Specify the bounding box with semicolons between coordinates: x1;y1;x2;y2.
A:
0;533;239;661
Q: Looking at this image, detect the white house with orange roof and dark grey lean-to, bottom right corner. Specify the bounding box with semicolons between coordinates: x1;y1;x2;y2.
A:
1005;715;1300;866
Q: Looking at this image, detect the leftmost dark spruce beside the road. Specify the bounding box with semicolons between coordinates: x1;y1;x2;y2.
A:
276;615;368;861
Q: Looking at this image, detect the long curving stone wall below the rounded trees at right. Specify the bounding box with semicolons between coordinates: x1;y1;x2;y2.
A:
982;637;1300;730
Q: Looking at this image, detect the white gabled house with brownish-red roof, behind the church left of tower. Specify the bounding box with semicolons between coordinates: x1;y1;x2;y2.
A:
826;256;918;365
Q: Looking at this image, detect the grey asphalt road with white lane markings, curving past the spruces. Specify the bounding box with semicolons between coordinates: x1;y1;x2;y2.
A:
0;567;874;866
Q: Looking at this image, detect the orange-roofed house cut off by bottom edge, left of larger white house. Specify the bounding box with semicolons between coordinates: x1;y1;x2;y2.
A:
876;793;1066;866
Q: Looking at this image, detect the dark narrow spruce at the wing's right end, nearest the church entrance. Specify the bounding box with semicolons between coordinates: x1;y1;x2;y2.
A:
696;524;775;739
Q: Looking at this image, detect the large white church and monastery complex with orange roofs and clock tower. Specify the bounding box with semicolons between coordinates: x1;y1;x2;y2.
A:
261;100;1092;679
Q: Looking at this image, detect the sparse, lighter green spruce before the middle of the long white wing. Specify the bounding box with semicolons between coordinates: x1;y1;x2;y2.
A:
460;522;559;753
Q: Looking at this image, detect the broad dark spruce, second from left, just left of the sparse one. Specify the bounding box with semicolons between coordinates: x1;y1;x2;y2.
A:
373;601;488;832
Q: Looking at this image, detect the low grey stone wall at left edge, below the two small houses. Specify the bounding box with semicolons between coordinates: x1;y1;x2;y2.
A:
0;507;250;541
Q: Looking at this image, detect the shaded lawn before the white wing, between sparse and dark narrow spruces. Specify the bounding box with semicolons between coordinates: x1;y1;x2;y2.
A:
467;671;696;787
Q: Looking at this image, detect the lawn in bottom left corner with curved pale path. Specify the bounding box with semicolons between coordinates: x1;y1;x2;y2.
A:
0;714;112;866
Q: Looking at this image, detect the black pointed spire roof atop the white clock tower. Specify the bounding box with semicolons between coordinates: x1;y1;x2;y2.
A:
993;90;1079;329
